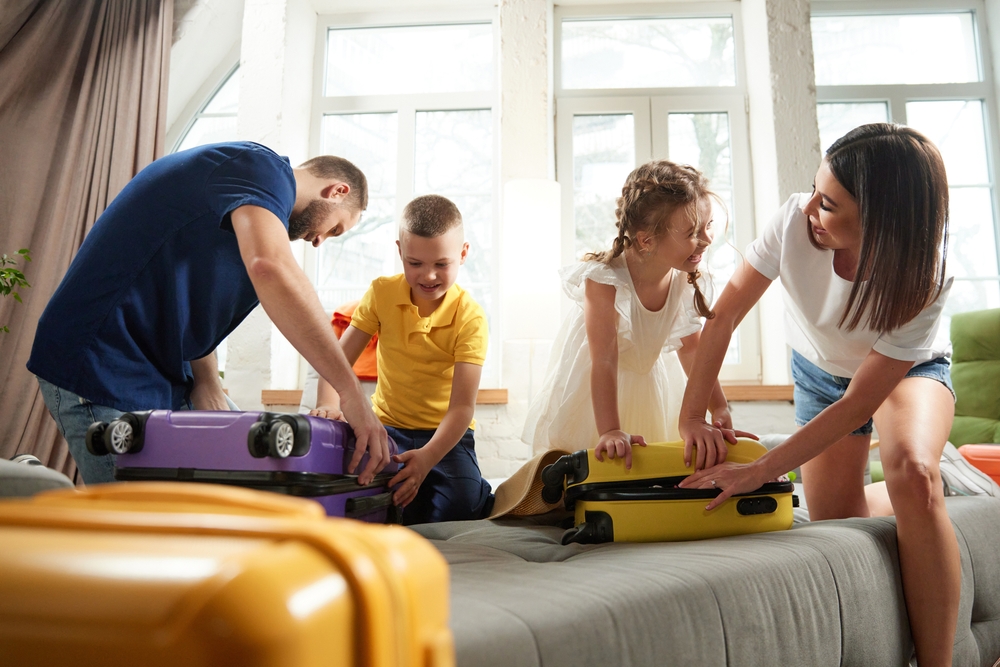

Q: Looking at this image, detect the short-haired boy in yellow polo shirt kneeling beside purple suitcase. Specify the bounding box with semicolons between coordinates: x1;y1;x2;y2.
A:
311;195;493;525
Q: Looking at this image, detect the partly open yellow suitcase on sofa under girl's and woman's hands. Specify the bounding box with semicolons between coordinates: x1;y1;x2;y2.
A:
542;438;798;544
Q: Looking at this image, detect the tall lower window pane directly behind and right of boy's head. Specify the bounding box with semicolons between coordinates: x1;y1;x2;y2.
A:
413;109;493;317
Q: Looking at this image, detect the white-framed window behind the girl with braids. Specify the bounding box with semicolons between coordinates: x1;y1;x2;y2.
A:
556;3;761;381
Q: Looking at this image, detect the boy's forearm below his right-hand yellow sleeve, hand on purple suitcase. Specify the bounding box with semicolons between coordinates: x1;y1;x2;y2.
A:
388;362;483;506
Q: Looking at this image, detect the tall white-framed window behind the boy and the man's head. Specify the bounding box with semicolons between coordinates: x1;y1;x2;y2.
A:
307;12;499;386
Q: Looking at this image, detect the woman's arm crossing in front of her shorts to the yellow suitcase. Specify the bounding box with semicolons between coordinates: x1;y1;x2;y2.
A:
680;350;913;509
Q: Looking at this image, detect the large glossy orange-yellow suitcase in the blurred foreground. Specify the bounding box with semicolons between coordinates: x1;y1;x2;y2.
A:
0;482;455;667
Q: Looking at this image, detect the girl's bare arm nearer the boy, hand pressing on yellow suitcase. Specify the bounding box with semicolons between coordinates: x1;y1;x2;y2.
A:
583;280;646;468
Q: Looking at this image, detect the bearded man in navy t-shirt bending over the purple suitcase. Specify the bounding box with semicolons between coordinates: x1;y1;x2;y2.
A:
28;142;389;484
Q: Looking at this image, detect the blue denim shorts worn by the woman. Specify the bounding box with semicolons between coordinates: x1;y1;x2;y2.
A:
792;350;955;435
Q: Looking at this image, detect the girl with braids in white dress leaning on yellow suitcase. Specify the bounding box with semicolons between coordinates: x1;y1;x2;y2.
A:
521;160;742;468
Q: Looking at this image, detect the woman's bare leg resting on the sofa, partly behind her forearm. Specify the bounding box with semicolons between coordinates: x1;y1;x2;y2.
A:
802;435;871;521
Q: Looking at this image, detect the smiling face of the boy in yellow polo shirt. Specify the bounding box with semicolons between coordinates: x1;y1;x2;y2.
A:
396;225;469;306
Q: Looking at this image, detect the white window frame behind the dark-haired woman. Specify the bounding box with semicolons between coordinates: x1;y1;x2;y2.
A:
811;0;1000;310
